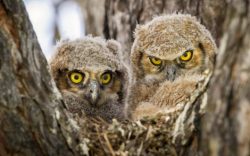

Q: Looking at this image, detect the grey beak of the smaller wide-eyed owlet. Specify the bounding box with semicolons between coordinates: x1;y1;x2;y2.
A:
88;81;99;104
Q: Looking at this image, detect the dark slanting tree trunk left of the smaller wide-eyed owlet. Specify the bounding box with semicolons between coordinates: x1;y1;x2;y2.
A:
0;0;80;156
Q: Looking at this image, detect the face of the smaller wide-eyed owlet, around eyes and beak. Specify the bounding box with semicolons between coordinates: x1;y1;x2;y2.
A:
63;69;122;107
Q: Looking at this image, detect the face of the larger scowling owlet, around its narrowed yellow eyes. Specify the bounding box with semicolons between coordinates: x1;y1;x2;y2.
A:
141;47;204;83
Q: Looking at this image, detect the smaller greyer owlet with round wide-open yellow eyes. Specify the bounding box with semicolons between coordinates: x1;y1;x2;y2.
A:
50;36;128;122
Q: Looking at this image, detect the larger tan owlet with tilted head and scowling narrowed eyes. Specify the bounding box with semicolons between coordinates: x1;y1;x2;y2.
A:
127;14;217;144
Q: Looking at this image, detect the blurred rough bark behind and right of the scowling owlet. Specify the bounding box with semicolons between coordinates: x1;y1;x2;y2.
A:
104;0;250;156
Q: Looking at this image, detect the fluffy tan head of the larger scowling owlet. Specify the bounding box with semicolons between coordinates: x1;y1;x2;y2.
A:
131;14;216;83
